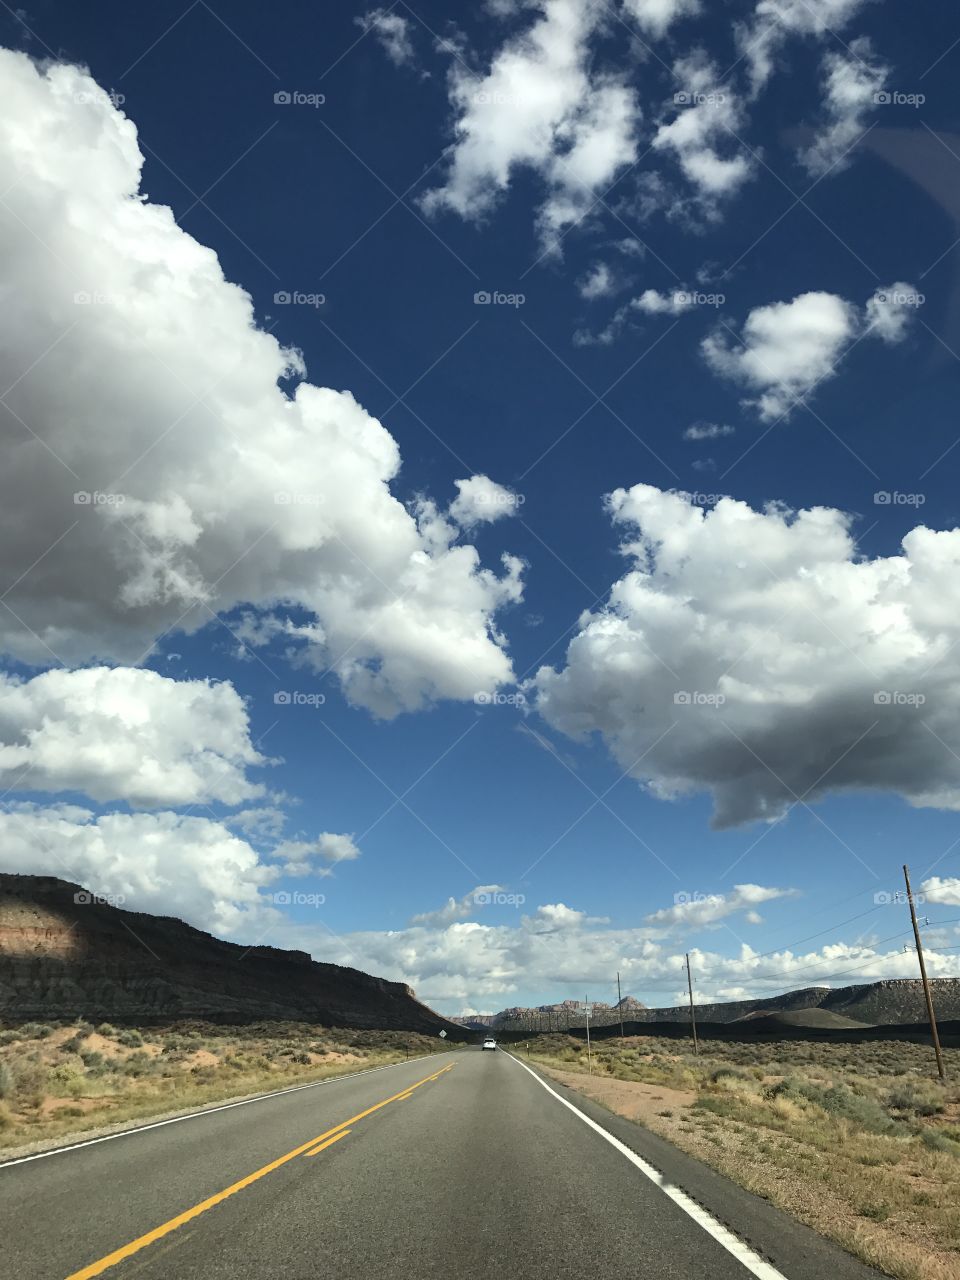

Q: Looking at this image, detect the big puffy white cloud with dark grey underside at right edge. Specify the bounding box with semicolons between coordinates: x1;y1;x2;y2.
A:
535;484;960;826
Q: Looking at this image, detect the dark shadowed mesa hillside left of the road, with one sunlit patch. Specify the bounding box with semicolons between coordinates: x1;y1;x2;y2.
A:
0;874;463;1038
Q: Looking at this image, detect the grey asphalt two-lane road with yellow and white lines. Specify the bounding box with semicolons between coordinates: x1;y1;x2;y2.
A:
0;1048;877;1280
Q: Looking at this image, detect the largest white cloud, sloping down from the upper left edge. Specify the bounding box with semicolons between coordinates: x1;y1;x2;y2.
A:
0;51;520;716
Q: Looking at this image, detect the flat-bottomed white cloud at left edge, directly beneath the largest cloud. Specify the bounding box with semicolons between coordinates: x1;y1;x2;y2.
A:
0;667;266;808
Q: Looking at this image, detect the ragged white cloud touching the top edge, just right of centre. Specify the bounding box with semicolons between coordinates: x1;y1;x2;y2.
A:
424;0;639;250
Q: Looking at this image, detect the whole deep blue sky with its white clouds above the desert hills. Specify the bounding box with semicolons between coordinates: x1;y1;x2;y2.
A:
0;0;960;1012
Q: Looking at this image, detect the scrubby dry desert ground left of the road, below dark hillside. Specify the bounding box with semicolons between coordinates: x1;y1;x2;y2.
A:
0;1021;448;1152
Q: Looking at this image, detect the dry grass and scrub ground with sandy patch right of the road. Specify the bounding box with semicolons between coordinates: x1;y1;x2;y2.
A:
515;1036;960;1280
